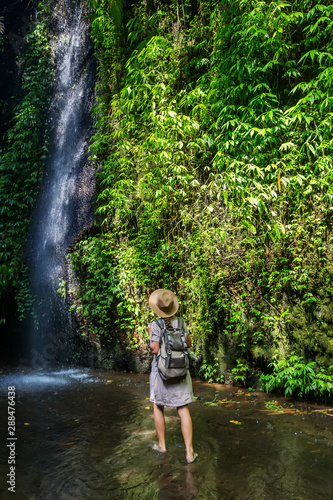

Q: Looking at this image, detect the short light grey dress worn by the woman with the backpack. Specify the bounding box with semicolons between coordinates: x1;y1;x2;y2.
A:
149;316;194;408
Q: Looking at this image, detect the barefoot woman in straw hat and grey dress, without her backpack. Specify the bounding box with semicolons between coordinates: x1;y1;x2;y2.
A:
148;289;198;463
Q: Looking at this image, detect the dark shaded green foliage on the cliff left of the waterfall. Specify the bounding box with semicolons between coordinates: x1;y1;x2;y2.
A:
0;22;52;314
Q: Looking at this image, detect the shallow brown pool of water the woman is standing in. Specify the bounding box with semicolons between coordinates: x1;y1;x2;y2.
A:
0;369;333;500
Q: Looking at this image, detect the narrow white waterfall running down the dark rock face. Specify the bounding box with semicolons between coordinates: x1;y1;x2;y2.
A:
28;0;95;368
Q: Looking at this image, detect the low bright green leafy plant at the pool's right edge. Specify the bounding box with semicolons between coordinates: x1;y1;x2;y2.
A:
260;352;333;397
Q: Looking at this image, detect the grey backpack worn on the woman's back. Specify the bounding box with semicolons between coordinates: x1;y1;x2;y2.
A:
155;318;189;382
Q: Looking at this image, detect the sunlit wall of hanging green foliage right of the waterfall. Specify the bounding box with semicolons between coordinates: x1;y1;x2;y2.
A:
68;0;333;390
